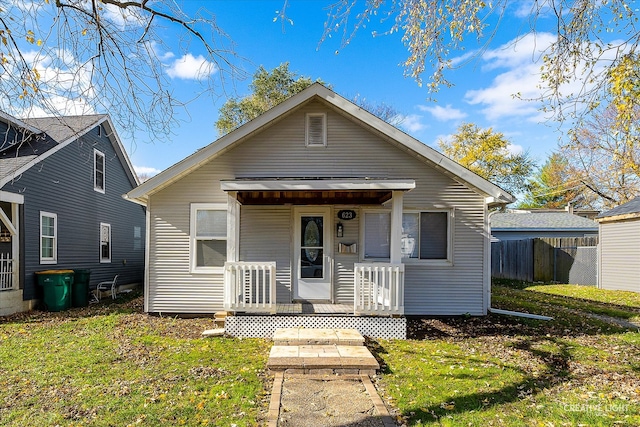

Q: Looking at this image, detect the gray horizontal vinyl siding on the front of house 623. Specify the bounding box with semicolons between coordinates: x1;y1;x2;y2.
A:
147;102;488;314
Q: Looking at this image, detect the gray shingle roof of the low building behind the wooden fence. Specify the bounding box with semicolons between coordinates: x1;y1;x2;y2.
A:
491;212;598;231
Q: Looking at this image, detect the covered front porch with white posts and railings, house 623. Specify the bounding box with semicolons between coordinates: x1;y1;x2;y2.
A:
221;179;415;316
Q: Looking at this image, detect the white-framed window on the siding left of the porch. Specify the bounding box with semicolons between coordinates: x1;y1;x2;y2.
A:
191;203;227;272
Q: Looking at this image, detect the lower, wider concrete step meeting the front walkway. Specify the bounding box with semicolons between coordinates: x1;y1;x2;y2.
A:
267;344;380;375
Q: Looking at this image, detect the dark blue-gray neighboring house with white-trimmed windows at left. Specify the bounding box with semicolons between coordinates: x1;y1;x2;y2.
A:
0;113;145;315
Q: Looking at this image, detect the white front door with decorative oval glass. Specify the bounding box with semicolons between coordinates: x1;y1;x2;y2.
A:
293;207;332;300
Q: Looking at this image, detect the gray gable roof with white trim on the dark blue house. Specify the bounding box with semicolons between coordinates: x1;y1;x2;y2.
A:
0;113;139;188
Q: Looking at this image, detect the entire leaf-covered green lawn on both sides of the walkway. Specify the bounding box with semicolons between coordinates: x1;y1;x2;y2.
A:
0;281;640;427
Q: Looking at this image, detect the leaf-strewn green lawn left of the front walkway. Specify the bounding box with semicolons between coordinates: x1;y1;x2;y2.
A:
0;296;269;426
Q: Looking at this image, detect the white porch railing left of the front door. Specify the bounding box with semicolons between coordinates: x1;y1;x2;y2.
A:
224;262;276;313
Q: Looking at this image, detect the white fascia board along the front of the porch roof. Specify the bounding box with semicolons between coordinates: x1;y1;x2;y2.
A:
220;179;416;191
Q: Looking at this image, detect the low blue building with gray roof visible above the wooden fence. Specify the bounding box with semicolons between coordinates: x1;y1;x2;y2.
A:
490;210;598;241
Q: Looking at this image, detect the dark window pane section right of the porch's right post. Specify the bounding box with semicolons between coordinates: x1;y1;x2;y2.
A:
401;211;451;261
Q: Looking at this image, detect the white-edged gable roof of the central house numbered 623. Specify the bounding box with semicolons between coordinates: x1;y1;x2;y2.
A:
125;83;515;205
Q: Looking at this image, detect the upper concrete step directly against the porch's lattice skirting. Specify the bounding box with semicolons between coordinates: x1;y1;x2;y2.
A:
273;328;364;346
